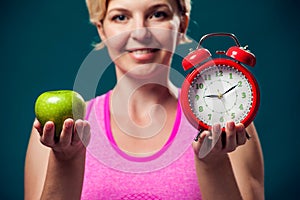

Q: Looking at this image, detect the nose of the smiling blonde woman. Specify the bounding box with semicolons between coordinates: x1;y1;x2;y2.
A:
131;20;151;41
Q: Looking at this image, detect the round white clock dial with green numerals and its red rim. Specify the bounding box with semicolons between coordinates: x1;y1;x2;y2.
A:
183;59;259;129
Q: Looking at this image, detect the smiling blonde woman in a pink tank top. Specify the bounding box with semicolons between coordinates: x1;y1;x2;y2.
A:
25;0;264;199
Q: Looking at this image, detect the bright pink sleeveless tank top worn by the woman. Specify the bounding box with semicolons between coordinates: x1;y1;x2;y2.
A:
81;93;201;200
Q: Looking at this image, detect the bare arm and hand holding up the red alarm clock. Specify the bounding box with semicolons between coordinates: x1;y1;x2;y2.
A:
194;124;264;200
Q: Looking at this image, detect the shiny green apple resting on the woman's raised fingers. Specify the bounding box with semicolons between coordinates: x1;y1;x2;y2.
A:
34;90;86;140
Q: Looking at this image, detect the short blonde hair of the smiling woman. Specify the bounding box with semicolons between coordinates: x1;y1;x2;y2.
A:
86;0;191;49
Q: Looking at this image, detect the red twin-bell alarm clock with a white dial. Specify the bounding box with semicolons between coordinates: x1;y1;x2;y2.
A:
180;33;260;132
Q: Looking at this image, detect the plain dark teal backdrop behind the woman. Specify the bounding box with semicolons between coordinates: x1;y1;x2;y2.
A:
0;0;300;199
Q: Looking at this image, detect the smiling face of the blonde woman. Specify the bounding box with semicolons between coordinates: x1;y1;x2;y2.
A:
98;0;185;76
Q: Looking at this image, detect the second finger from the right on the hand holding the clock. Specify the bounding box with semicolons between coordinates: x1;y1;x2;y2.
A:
224;122;237;152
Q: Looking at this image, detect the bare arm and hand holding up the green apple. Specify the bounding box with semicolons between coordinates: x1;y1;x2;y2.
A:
25;119;89;199
